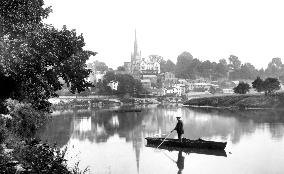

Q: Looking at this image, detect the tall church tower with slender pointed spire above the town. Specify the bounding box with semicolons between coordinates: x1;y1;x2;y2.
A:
131;29;141;79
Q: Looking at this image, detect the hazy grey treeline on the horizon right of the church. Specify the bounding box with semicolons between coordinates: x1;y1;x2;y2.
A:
161;52;284;81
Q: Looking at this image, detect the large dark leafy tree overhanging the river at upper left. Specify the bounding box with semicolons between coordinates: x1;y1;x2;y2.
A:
0;0;95;109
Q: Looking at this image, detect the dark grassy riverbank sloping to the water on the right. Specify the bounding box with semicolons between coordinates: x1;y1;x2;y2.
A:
184;93;284;109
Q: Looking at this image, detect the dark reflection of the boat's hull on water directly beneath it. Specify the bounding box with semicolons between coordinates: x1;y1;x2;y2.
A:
147;145;227;157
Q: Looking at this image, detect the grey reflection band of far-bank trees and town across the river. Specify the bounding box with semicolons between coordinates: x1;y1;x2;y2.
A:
40;106;284;147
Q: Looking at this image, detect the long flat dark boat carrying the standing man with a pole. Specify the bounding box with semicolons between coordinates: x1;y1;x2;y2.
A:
145;137;227;150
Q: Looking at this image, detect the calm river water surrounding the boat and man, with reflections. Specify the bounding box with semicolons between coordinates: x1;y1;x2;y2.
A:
40;106;284;174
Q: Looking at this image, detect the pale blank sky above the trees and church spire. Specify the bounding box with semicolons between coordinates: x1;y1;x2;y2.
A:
45;0;284;69
